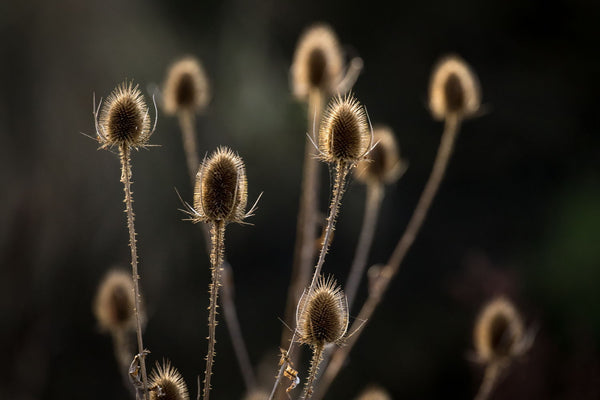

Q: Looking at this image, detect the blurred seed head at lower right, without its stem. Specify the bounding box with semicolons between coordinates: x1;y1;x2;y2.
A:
474;297;524;363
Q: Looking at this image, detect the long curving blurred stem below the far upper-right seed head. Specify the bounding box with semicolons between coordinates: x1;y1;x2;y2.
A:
314;115;460;400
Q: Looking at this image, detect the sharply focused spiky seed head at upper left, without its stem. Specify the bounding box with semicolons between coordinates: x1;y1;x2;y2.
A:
98;81;150;148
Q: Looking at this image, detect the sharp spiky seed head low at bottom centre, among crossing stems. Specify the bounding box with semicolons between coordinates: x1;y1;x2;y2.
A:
296;276;348;346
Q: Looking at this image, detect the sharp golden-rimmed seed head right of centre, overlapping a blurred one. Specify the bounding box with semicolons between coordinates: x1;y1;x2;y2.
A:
319;94;372;163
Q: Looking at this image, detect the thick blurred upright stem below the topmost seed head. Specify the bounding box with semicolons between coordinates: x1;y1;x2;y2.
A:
281;89;323;346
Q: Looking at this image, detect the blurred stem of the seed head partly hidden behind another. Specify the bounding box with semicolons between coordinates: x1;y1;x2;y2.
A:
344;182;384;309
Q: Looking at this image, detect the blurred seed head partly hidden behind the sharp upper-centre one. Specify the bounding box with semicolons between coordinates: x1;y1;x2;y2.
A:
355;126;405;183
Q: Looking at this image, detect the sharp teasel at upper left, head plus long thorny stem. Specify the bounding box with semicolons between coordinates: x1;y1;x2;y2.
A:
93;81;158;399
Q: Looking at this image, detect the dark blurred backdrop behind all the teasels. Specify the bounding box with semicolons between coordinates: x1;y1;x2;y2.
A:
0;0;600;399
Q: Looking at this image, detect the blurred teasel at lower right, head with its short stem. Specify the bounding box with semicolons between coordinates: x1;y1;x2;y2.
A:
473;297;533;400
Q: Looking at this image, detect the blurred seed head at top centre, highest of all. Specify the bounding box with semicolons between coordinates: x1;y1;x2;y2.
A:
291;24;344;100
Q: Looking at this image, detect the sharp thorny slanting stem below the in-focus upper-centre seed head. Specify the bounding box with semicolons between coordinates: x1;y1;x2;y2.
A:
269;162;353;400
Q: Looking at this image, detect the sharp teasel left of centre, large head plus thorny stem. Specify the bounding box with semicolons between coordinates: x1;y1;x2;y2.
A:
183;147;260;400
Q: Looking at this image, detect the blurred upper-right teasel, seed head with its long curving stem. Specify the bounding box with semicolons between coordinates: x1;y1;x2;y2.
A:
315;56;481;399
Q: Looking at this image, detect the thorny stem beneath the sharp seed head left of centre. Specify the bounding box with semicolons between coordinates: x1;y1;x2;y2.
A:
203;220;225;400
